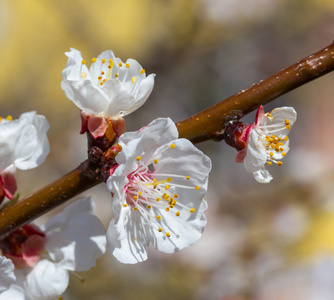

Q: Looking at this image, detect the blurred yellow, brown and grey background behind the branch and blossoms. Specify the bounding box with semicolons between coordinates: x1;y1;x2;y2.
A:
0;0;334;300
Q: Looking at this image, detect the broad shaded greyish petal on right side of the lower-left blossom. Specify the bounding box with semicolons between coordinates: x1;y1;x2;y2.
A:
45;199;106;271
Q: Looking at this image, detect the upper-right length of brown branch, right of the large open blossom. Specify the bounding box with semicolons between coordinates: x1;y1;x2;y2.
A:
176;43;334;143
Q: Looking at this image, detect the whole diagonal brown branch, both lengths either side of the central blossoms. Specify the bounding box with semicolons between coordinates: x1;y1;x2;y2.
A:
0;43;334;239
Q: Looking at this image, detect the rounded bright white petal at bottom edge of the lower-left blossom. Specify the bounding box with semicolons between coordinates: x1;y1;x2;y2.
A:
25;259;69;300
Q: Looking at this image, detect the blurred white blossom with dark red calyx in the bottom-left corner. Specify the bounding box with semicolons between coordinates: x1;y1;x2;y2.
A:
0;198;106;300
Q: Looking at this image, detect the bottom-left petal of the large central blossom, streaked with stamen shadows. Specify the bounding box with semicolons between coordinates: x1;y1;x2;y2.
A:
107;207;151;264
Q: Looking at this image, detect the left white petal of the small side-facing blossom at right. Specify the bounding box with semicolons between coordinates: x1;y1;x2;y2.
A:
244;129;267;173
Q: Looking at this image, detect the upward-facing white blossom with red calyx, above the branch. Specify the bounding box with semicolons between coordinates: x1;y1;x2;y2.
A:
61;48;155;138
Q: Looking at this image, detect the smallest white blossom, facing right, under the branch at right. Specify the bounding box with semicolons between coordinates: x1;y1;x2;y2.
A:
236;106;297;183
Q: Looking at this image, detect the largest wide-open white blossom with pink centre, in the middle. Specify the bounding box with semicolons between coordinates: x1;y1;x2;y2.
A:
107;118;211;264
